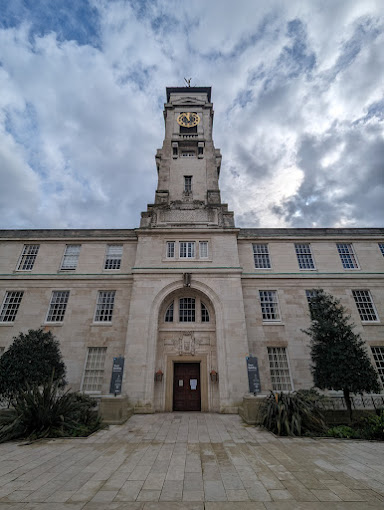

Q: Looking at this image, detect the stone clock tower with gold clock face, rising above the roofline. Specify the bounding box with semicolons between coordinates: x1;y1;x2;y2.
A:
140;87;234;228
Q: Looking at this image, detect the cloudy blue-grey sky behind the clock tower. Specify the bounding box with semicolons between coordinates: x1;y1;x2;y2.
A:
0;0;384;228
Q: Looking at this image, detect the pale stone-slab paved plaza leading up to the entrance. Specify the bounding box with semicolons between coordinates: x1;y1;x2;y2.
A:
0;413;384;510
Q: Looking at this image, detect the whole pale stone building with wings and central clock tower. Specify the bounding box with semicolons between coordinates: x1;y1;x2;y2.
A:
0;87;384;412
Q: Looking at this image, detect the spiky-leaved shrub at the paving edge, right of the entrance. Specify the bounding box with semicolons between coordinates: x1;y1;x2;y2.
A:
261;390;325;436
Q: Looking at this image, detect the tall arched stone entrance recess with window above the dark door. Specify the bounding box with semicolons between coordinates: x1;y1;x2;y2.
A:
154;288;219;411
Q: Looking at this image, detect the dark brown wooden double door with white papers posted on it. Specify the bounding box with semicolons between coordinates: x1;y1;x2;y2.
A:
173;363;201;411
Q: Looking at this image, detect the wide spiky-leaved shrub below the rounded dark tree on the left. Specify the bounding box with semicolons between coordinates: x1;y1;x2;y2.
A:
0;377;100;443
